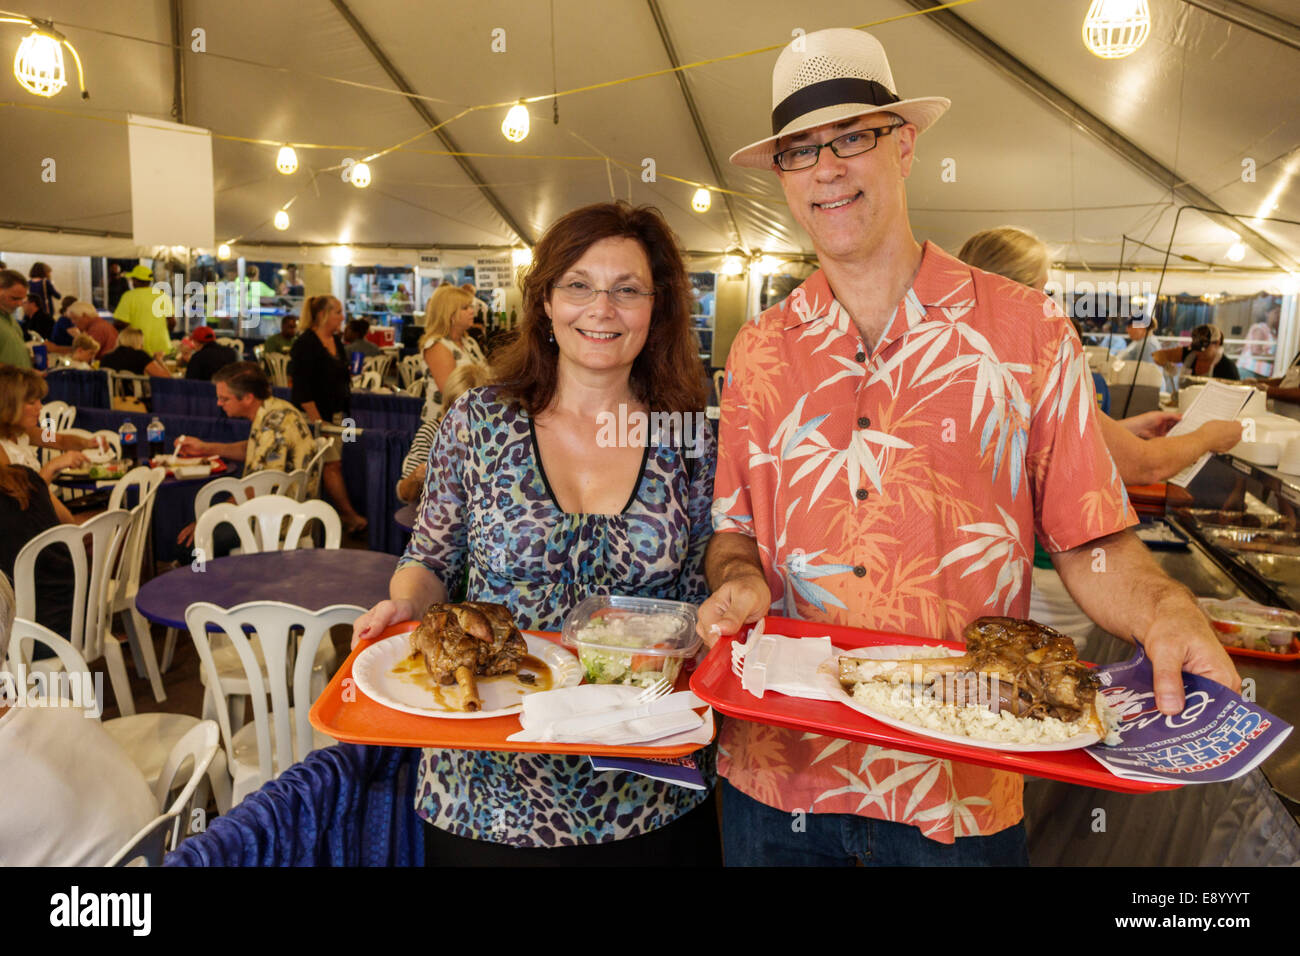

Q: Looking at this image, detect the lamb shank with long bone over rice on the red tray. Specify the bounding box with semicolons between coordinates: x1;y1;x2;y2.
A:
840;618;1101;723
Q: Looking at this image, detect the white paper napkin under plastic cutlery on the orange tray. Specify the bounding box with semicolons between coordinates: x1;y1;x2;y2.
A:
506;684;714;747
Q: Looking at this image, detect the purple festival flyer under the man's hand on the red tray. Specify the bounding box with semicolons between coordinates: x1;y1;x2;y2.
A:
1088;646;1291;783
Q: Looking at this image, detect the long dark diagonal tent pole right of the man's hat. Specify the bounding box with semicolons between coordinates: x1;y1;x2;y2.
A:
907;0;1300;272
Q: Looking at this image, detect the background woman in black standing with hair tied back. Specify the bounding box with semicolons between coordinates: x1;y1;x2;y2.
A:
289;295;367;535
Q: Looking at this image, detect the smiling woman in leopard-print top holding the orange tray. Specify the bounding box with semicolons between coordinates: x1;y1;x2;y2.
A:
352;203;719;865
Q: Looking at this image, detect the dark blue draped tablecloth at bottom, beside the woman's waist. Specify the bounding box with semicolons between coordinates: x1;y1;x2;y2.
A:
163;744;425;866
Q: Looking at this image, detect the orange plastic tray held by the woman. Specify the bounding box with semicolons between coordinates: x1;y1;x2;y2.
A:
308;620;703;760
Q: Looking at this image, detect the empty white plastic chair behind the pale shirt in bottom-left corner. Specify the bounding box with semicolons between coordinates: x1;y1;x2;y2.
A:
8;618;230;832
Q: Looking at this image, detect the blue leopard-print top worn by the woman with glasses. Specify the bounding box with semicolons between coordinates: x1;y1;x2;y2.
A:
398;388;718;847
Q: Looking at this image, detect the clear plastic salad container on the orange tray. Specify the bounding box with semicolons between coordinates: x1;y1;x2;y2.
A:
562;594;701;687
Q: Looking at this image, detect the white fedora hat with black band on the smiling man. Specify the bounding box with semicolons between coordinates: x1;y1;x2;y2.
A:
731;27;952;169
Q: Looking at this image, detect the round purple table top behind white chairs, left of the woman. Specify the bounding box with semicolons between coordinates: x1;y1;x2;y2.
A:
135;548;398;631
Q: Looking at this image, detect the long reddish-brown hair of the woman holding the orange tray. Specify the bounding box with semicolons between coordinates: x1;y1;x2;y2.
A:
493;202;709;415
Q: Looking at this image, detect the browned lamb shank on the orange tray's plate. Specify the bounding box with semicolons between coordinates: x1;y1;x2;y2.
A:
411;601;528;711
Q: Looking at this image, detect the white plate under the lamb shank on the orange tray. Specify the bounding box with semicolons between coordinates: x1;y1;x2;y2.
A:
352;633;582;721
